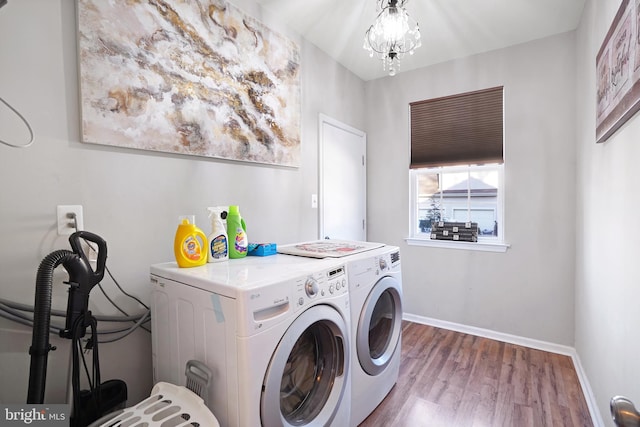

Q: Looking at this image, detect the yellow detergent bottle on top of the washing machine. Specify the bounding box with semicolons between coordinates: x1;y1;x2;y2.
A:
173;215;208;267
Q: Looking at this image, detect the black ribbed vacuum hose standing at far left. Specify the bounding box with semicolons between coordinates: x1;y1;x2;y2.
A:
27;250;74;404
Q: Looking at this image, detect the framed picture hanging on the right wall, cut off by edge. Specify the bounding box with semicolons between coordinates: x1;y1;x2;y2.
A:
596;0;640;143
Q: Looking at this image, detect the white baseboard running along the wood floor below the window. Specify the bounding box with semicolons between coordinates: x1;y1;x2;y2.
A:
402;313;605;427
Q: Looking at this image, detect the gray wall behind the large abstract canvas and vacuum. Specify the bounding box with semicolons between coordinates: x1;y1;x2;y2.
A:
0;0;365;403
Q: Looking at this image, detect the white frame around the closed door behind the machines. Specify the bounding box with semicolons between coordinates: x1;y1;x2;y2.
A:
318;113;367;241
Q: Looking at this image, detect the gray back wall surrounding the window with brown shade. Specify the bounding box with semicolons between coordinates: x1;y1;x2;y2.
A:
366;32;575;345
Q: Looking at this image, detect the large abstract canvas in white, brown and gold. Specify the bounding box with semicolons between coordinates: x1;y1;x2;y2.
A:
77;0;300;167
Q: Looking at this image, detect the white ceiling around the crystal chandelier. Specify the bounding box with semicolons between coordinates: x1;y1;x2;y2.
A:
257;0;585;80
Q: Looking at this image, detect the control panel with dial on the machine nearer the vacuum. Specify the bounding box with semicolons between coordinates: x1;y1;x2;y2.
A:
294;265;349;310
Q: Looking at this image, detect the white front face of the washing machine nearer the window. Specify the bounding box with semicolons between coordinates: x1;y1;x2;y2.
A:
344;246;402;427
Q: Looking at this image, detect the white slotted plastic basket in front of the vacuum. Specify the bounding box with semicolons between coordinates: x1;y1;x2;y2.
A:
91;382;220;427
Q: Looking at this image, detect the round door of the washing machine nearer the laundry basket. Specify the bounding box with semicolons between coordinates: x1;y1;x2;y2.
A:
260;305;349;427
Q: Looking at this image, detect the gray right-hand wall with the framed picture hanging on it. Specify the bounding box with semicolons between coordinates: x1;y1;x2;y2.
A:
575;0;640;426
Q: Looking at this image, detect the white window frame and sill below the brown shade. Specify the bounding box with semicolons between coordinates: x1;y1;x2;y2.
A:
405;164;509;252
